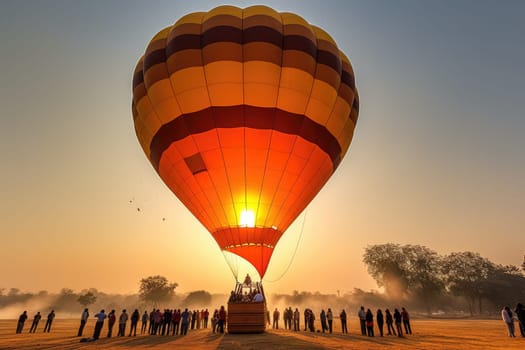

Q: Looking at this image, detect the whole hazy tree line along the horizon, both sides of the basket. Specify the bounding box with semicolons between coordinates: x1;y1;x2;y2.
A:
0;247;525;317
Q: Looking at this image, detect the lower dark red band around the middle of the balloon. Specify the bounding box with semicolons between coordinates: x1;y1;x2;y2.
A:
150;106;341;171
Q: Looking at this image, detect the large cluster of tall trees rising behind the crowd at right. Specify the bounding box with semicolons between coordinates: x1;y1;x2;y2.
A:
363;243;525;315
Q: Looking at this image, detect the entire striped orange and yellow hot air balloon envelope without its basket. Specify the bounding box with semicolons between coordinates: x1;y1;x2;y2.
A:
132;6;359;277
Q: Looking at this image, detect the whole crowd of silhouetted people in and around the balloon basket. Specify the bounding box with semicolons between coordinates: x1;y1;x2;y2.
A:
16;300;525;341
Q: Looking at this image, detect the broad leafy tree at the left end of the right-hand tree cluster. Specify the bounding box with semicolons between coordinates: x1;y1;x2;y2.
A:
363;243;444;313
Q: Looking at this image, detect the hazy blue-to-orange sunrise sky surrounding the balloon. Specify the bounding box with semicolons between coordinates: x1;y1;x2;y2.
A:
0;0;525;293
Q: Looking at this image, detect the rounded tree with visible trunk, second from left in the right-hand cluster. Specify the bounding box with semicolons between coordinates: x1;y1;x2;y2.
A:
442;252;496;315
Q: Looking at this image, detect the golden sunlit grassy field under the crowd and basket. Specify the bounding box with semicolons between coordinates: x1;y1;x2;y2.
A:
0;319;525;350
